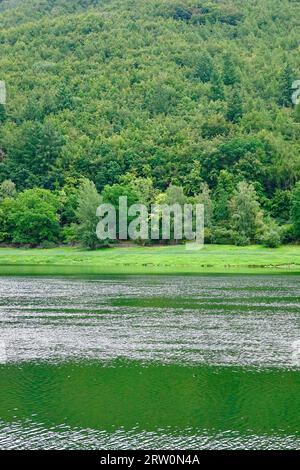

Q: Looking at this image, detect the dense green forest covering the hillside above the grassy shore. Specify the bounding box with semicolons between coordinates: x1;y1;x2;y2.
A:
0;0;300;248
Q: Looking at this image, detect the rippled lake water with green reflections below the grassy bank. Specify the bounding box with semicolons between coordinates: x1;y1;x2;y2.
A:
0;275;300;449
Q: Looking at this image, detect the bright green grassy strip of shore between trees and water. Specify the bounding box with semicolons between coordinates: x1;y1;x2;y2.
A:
0;245;300;274
